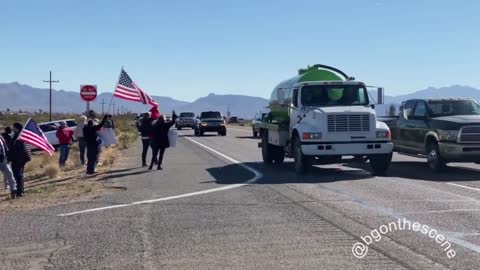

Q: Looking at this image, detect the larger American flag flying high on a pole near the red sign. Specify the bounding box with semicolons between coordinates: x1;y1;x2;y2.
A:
113;68;158;106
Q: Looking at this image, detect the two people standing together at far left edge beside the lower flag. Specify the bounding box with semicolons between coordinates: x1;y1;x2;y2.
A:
0;123;32;199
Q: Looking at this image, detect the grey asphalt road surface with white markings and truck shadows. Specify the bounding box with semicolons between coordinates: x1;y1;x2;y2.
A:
0;128;480;269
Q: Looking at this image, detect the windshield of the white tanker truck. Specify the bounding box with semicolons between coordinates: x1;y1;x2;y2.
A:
301;84;369;106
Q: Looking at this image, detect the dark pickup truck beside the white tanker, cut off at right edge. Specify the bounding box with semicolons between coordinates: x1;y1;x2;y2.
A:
385;98;480;172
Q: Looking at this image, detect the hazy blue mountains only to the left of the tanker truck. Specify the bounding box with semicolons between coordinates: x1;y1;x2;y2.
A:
0;82;268;118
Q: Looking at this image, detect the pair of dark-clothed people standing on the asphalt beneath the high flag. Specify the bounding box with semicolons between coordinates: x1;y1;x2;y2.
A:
137;111;177;170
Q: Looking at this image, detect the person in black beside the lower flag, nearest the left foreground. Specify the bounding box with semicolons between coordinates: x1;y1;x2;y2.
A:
9;123;32;197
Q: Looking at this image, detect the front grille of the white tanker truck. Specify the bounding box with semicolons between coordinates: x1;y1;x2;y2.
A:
327;114;370;132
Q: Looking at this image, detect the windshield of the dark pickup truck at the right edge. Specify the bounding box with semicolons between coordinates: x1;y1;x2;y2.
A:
428;100;480;117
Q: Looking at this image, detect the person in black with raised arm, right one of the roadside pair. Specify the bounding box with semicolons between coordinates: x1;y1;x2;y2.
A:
148;112;177;170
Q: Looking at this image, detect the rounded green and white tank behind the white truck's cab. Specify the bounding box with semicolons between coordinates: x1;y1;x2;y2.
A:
267;65;347;124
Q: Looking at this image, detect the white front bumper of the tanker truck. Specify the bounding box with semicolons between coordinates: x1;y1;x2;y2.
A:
302;141;393;156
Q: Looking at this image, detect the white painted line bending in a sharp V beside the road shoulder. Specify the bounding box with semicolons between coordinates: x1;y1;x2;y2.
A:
57;137;263;217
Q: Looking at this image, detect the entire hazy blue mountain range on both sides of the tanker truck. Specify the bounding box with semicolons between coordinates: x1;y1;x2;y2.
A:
0;82;480;118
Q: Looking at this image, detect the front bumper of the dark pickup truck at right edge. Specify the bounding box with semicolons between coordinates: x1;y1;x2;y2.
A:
438;142;480;162
